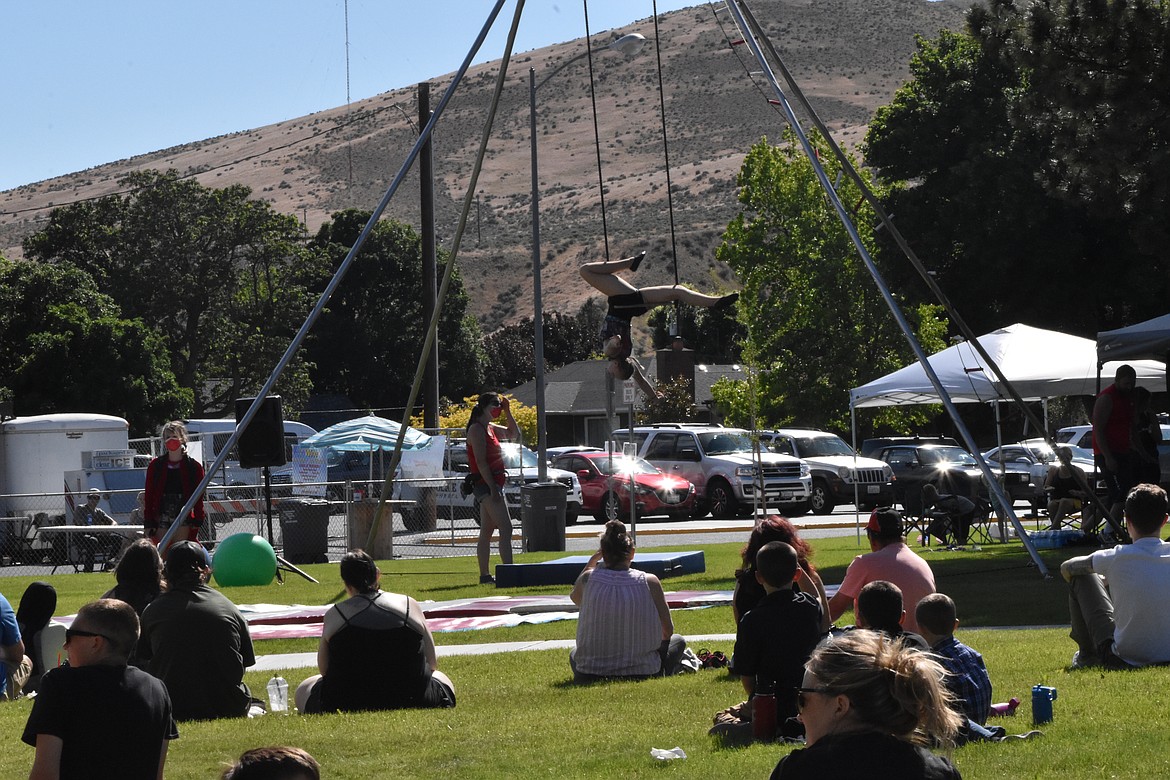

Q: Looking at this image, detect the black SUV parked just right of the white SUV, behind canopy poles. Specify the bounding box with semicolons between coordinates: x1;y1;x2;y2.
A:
878;443;1030;516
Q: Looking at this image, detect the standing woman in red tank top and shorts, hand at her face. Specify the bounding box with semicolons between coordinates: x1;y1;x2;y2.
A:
467;393;519;584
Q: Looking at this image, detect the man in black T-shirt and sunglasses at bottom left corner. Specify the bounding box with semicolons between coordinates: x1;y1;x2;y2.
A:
21;599;179;780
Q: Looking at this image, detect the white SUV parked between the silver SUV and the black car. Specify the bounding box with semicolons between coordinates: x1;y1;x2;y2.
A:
759;428;894;515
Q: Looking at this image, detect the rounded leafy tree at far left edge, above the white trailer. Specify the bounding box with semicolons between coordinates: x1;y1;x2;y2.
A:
0;257;191;434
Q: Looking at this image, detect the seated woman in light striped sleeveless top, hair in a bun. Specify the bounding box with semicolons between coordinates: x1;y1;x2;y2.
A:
569;520;687;683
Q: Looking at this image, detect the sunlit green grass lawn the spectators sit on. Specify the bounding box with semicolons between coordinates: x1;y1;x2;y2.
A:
0;538;1170;780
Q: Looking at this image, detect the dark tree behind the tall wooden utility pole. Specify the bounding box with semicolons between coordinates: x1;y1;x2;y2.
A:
309;209;483;408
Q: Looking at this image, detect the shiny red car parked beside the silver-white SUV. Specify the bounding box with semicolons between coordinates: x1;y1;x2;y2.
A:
552;450;695;523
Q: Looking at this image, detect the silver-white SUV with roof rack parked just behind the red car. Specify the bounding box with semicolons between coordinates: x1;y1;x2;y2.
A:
611;422;812;519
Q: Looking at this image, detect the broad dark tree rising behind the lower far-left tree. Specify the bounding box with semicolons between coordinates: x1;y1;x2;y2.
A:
25;171;322;416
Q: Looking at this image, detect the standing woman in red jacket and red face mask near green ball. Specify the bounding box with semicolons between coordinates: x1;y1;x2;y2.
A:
143;420;204;554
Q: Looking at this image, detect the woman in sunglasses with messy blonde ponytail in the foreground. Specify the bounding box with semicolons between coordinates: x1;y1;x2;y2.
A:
772;628;962;780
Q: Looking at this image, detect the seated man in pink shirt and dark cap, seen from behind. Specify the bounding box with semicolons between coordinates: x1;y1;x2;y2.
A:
828;506;935;634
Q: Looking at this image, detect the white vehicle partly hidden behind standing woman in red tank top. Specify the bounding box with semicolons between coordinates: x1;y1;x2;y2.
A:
418;442;581;525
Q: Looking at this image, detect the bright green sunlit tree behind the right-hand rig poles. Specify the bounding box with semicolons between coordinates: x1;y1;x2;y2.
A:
717;131;942;427
